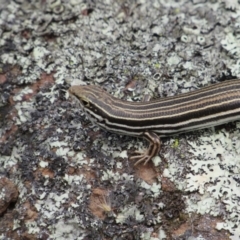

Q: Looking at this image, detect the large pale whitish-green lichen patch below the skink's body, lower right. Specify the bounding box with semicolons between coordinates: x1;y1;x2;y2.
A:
165;129;240;237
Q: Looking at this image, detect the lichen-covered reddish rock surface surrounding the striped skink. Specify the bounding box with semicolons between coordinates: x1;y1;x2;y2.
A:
0;0;240;240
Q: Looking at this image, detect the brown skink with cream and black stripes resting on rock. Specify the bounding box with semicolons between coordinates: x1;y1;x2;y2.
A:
69;80;240;165
